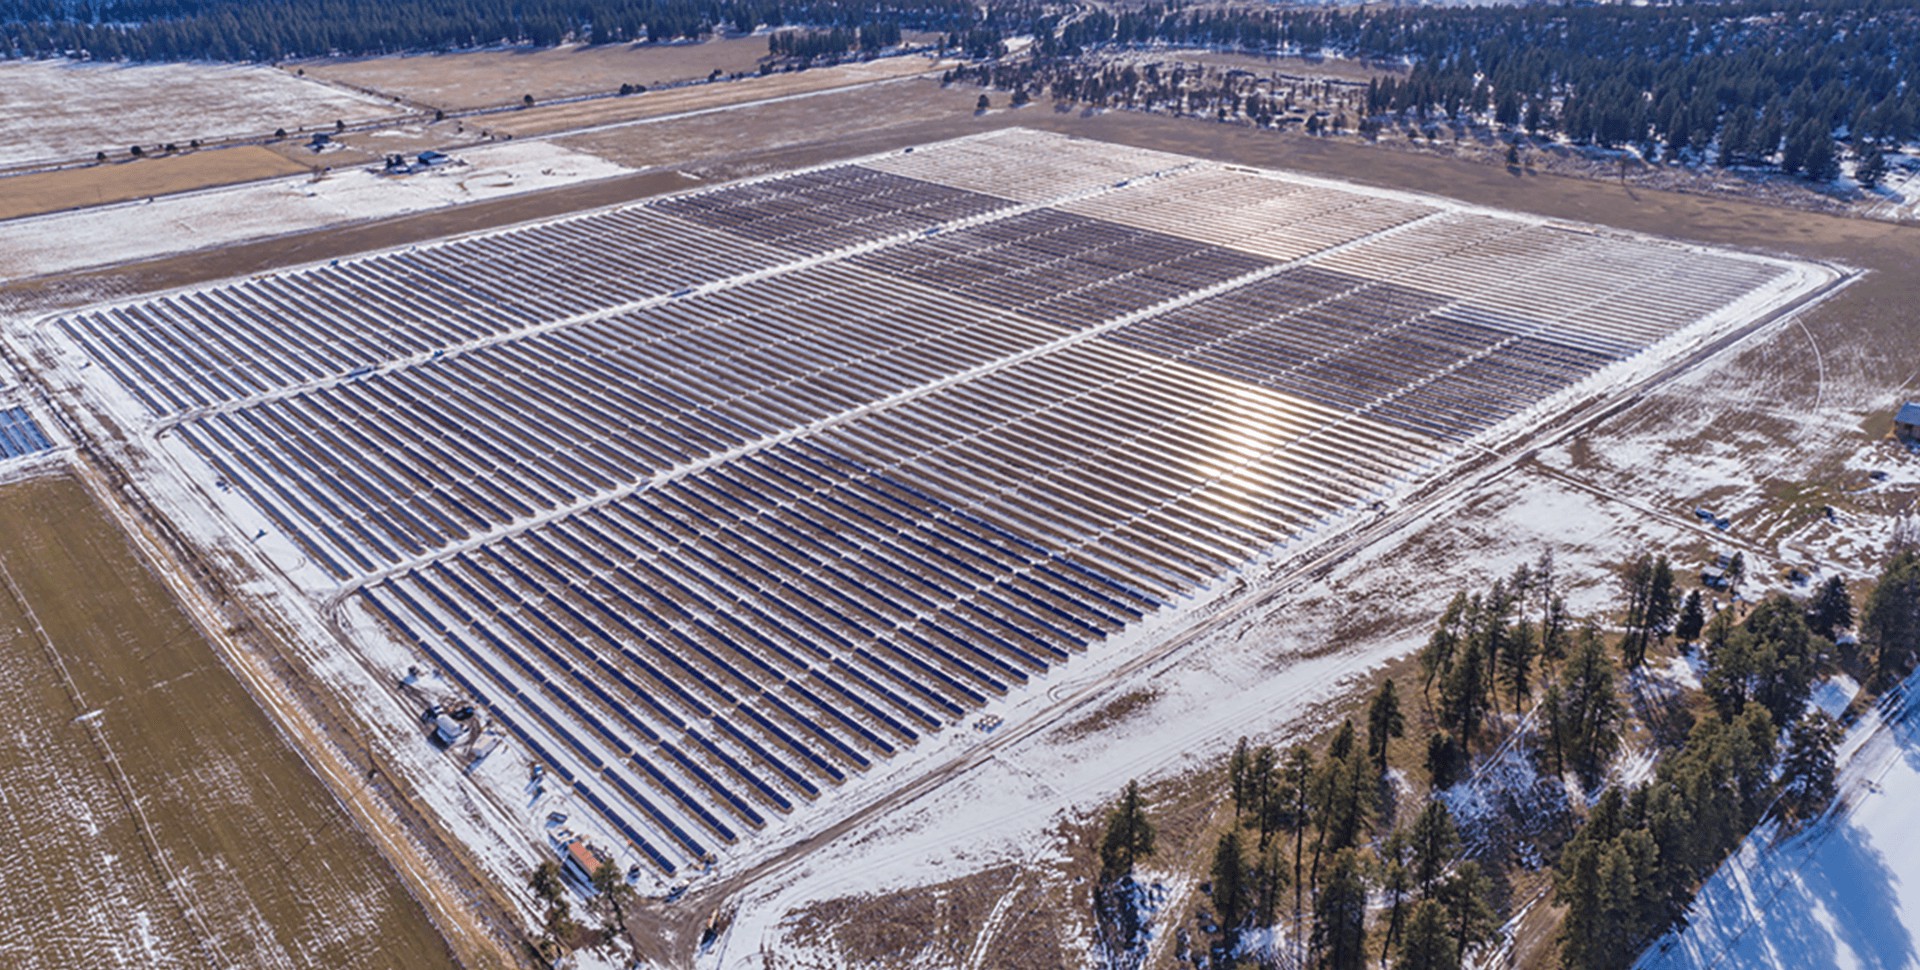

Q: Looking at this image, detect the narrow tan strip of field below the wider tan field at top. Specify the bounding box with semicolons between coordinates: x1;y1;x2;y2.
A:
493;58;937;136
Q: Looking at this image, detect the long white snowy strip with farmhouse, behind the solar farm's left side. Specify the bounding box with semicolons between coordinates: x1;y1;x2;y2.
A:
0;142;632;279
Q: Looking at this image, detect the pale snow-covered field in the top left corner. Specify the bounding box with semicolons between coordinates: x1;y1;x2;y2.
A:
0;61;397;169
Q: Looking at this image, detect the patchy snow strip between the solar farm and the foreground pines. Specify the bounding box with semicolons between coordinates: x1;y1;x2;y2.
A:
699;460;1712;968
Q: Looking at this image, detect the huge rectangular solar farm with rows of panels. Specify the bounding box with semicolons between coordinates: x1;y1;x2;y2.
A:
45;129;1834;876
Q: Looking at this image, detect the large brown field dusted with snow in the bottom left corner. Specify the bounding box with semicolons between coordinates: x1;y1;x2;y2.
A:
0;476;453;970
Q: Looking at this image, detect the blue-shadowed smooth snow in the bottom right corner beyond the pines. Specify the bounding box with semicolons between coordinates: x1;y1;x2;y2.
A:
1640;678;1920;970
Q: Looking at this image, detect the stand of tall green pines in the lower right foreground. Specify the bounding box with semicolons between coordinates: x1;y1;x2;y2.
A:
1092;551;1920;970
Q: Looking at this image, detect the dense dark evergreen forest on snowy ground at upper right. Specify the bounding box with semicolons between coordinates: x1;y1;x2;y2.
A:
1035;0;1920;181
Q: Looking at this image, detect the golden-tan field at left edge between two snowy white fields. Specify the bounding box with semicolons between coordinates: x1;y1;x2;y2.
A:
0;144;307;219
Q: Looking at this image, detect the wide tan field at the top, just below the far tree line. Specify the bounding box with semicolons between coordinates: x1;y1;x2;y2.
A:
288;36;783;111
